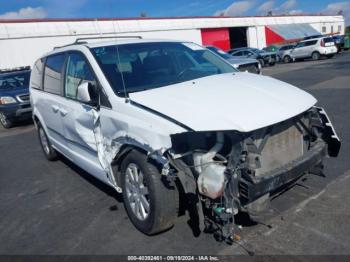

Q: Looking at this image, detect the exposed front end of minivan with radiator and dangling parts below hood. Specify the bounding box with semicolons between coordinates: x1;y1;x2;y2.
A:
168;107;340;244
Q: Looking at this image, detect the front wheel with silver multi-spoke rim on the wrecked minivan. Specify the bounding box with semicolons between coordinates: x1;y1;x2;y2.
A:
120;150;179;235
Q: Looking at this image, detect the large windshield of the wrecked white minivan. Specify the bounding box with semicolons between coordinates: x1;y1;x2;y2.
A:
91;42;236;94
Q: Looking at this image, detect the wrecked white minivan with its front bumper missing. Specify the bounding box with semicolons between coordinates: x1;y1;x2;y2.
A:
30;37;340;240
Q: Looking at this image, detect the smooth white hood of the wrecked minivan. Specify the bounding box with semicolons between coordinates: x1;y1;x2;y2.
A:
130;73;317;132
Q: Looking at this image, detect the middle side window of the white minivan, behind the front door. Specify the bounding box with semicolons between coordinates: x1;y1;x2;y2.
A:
44;54;65;95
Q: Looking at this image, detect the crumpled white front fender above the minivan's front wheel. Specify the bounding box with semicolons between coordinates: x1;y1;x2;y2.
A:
94;101;185;191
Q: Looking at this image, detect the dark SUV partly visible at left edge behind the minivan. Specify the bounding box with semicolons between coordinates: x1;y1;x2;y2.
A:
0;67;32;128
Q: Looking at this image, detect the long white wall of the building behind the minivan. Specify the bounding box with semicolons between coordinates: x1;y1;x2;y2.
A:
0;16;344;68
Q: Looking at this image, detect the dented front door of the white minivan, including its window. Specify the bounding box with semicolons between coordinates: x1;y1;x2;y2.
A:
61;52;107;181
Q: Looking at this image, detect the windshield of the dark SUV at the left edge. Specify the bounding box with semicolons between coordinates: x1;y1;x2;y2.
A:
0;72;30;90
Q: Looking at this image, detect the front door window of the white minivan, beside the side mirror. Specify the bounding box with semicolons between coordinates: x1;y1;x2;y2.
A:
64;53;96;99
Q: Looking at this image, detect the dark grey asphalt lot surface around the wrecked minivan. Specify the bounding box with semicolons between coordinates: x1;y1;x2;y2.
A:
0;52;350;255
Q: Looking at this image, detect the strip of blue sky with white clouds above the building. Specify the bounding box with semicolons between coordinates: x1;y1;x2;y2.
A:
0;0;350;24
